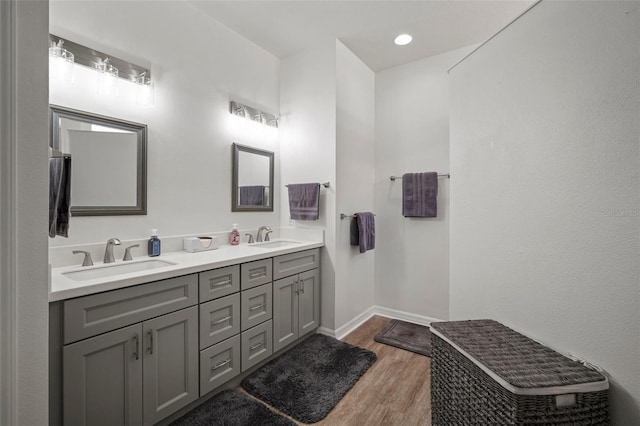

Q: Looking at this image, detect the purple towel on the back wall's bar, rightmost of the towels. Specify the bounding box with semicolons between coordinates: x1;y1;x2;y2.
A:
402;172;438;217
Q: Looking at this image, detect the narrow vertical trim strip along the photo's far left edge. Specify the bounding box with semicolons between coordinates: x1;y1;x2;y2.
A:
0;1;18;425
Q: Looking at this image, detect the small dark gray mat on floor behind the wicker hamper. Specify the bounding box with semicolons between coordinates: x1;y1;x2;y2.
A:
373;320;431;357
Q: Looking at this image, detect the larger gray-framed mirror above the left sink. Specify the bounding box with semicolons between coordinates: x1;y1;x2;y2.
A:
50;105;147;216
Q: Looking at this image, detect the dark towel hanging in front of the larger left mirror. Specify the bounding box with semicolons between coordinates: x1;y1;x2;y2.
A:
49;157;71;238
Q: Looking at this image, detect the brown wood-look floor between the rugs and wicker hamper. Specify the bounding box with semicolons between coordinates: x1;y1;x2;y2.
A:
242;316;431;426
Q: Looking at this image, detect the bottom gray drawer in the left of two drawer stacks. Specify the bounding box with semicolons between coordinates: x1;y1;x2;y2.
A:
200;334;240;396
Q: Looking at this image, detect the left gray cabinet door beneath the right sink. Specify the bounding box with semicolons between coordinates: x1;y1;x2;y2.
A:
273;276;298;352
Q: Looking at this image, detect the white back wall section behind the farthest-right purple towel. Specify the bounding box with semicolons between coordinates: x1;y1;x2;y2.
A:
374;47;473;319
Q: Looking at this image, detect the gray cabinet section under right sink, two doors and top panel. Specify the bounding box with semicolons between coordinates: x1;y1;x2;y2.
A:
273;249;320;352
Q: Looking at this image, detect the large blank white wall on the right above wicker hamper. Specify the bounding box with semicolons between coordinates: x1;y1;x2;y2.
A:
450;1;640;425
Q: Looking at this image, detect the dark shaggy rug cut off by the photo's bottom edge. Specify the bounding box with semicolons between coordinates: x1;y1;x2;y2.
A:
170;390;295;426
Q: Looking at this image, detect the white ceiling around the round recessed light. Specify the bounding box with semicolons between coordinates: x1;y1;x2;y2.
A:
188;0;534;71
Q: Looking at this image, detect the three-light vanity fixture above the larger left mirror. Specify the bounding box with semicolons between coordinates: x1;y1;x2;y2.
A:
49;34;154;106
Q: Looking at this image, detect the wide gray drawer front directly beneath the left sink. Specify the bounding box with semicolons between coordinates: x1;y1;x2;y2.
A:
63;274;198;344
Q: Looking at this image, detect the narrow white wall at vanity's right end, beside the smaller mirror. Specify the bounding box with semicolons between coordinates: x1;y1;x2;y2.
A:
280;42;336;330
